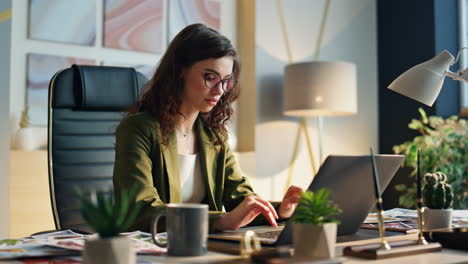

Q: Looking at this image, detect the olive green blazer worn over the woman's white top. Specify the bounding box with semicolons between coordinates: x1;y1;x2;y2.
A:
113;113;279;232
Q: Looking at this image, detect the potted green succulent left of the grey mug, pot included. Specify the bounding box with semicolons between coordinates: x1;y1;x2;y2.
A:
80;186;140;264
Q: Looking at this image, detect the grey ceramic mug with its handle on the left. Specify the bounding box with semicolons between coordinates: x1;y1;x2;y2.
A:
151;204;208;256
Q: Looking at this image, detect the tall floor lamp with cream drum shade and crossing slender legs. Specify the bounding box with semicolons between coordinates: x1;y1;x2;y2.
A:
276;0;357;190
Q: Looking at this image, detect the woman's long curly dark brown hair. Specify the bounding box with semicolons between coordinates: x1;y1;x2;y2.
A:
134;24;240;146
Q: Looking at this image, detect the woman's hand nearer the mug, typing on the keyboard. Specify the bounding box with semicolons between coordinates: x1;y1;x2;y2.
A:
214;195;278;230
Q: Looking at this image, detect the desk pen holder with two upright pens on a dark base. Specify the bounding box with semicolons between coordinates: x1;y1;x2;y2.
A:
343;148;442;259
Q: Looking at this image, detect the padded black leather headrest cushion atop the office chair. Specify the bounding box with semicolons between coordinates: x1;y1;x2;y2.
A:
72;65;139;111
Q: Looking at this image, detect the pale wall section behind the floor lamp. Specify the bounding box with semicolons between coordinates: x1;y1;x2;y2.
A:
253;0;378;200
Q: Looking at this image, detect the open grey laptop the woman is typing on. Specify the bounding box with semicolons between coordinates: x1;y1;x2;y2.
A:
209;155;405;246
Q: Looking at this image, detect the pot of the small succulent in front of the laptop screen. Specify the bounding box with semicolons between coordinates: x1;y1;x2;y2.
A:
293;223;337;260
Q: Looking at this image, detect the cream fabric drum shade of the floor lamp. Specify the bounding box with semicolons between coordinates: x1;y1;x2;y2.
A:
283;61;357;116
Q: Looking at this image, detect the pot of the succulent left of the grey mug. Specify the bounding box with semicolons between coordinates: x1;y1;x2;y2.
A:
83;237;136;264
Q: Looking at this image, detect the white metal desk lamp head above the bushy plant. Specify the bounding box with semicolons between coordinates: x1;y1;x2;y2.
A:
388;50;455;106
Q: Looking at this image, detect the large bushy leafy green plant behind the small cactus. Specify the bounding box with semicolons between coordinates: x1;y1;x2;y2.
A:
393;108;468;209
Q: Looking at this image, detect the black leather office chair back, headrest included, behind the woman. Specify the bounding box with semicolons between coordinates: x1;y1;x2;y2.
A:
48;65;147;231
